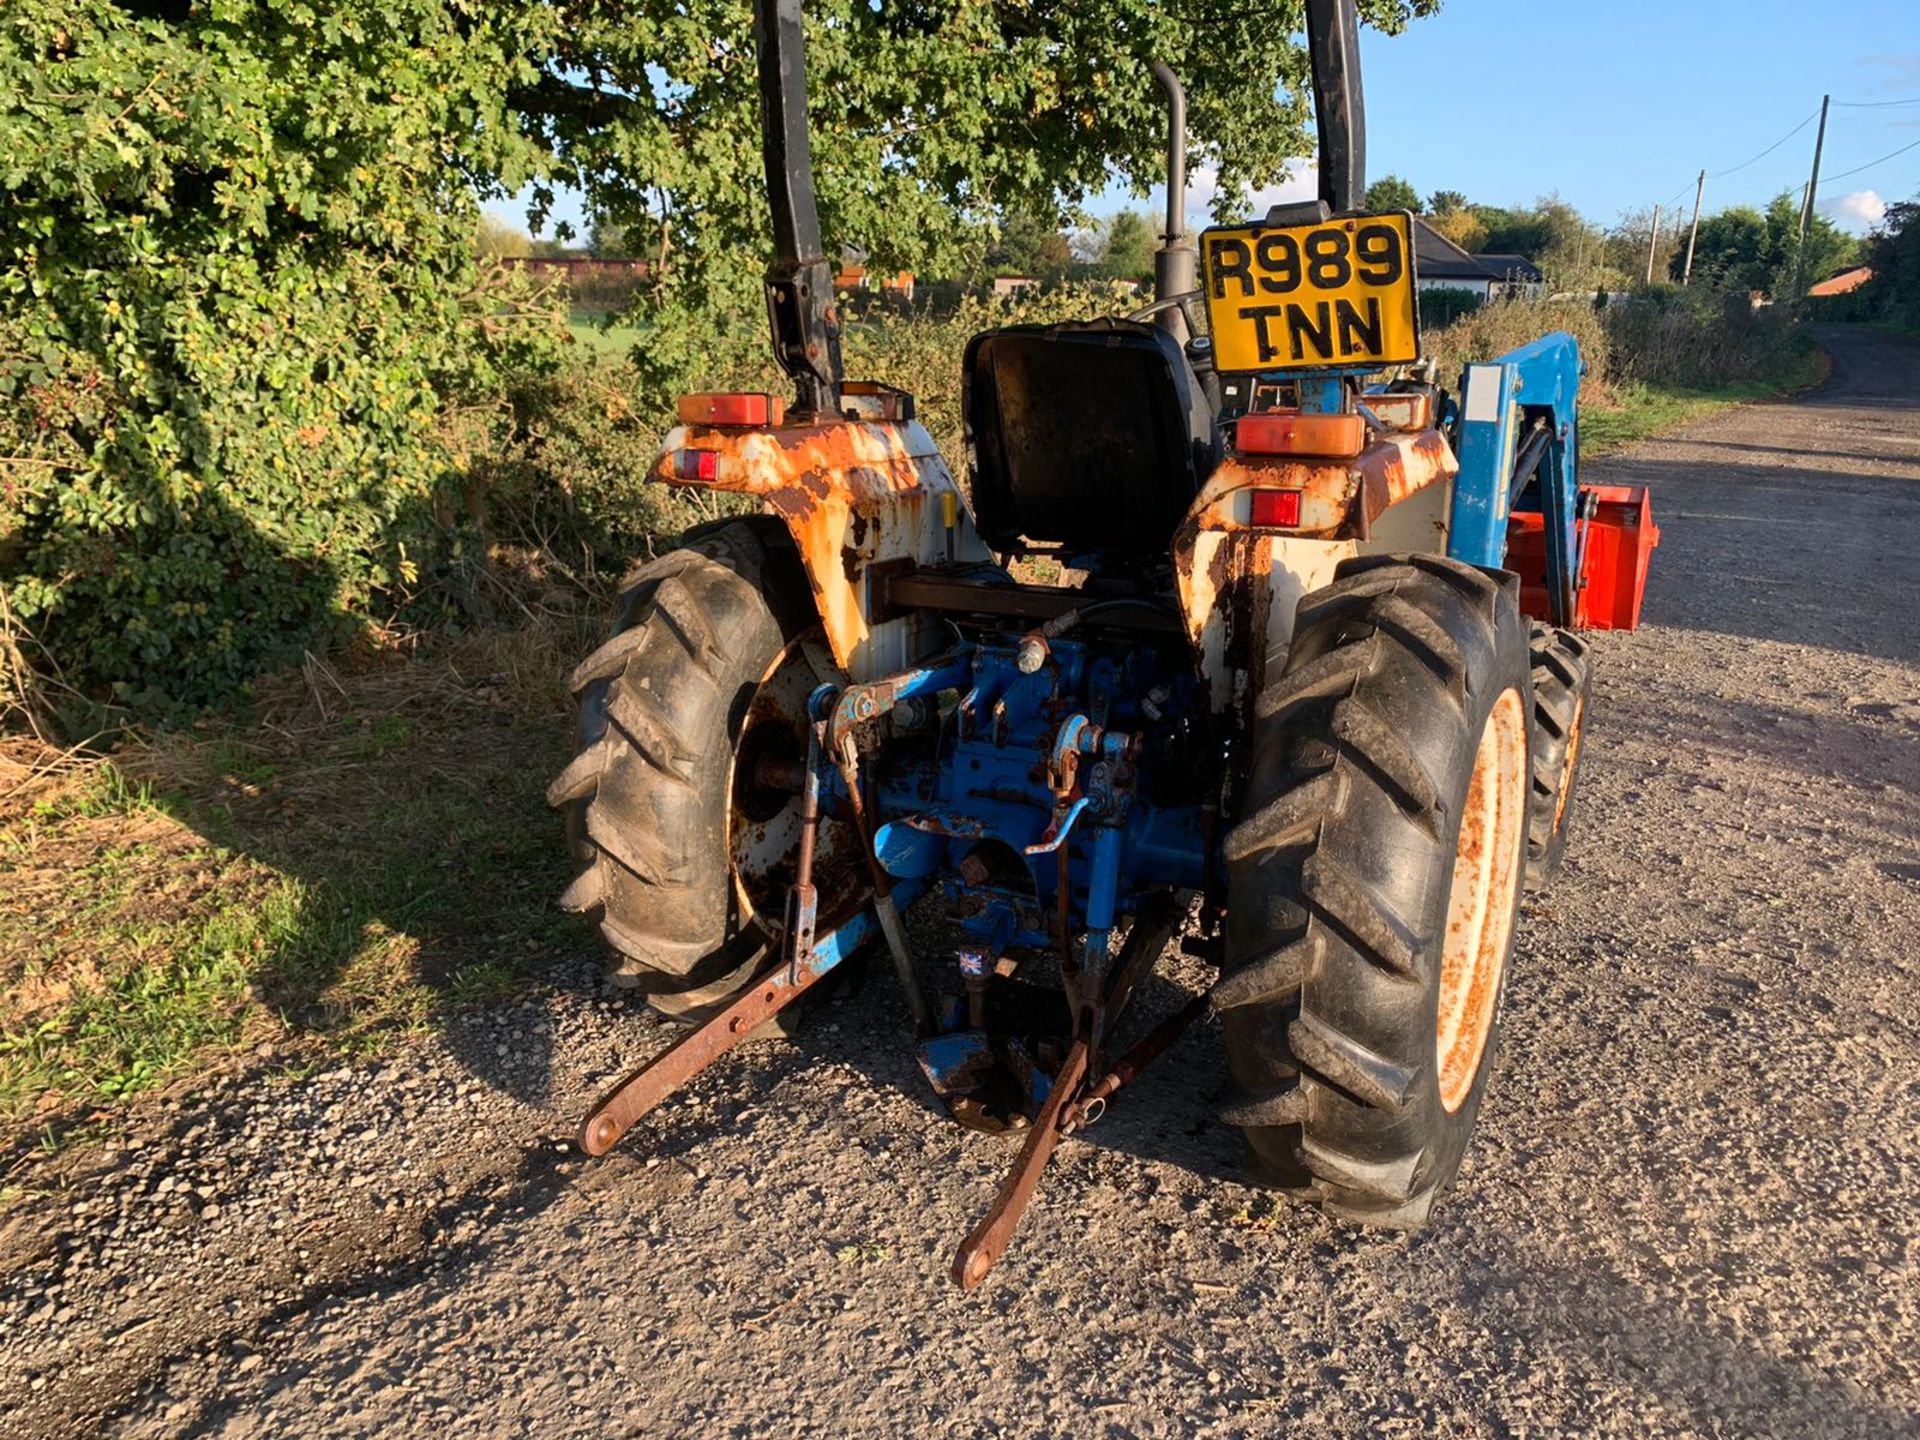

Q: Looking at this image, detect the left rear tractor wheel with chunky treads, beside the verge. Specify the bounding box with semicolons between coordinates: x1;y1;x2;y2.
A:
547;516;856;1023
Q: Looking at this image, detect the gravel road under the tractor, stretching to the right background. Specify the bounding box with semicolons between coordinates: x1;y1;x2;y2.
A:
0;330;1920;1440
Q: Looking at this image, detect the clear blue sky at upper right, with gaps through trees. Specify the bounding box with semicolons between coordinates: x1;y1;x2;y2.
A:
490;0;1920;243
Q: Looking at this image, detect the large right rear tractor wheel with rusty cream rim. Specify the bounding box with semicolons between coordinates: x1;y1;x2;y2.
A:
1213;555;1532;1229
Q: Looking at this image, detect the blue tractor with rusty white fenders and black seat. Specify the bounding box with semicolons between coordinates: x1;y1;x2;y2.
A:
551;0;1645;1286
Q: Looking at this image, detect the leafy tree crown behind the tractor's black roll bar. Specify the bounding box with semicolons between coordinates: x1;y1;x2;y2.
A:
515;0;1436;394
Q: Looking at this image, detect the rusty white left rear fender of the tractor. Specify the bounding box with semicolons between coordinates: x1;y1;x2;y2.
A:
651;420;993;682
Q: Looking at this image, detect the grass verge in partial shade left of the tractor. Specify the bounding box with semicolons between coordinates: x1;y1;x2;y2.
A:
0;622;588;1148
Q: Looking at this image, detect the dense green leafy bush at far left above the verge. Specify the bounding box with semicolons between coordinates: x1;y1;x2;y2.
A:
0;0;551;712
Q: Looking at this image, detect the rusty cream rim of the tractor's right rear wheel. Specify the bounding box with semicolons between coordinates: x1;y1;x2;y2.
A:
1434;689;1526;1112
